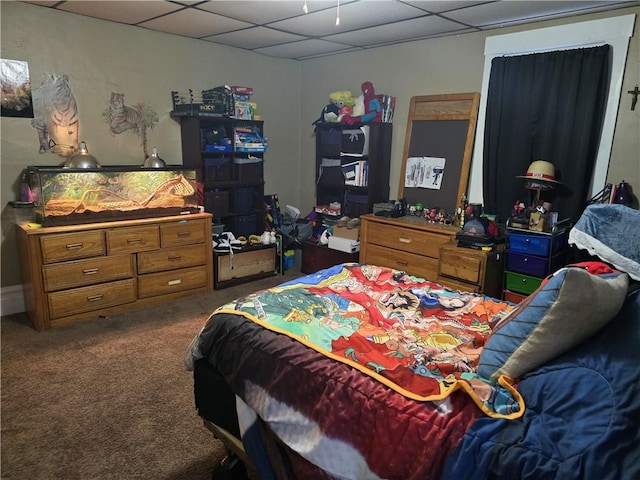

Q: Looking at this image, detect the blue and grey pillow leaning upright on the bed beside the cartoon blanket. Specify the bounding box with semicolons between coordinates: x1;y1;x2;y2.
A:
477;267;629;381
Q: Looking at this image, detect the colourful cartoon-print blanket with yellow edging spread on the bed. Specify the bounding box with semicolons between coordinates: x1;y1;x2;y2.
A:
214;264;524;418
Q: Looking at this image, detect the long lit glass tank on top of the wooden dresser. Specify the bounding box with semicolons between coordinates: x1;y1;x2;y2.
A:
27;166;199;227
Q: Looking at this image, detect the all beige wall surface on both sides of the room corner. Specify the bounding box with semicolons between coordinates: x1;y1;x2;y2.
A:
0;1;640;287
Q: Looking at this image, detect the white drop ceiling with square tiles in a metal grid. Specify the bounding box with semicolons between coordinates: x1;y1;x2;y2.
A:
20;0;640;60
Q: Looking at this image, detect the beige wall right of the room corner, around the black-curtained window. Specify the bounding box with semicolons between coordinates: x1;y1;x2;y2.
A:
301;7;640;216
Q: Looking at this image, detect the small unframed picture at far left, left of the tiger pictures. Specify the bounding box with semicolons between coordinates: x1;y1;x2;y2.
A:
0;59;33;118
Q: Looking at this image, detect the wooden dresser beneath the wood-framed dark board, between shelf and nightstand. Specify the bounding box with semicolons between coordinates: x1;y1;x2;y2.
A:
360;214;459;282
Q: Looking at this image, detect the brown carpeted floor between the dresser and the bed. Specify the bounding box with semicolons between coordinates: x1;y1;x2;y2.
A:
0;267;300;480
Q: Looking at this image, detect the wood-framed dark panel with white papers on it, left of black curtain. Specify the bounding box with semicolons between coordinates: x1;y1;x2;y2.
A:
398;93;480;214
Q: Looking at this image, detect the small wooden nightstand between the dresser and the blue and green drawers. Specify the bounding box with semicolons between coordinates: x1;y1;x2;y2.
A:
438;242;505;298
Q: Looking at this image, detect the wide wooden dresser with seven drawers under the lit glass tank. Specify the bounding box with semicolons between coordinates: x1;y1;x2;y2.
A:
18;213;213;330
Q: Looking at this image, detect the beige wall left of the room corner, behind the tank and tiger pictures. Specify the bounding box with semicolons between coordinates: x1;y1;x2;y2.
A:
0;1;301;287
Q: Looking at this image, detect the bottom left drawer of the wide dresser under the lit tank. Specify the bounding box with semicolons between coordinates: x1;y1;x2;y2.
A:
48;279;136;319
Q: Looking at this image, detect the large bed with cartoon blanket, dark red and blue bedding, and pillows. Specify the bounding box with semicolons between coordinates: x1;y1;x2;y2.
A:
186;205;640;480
